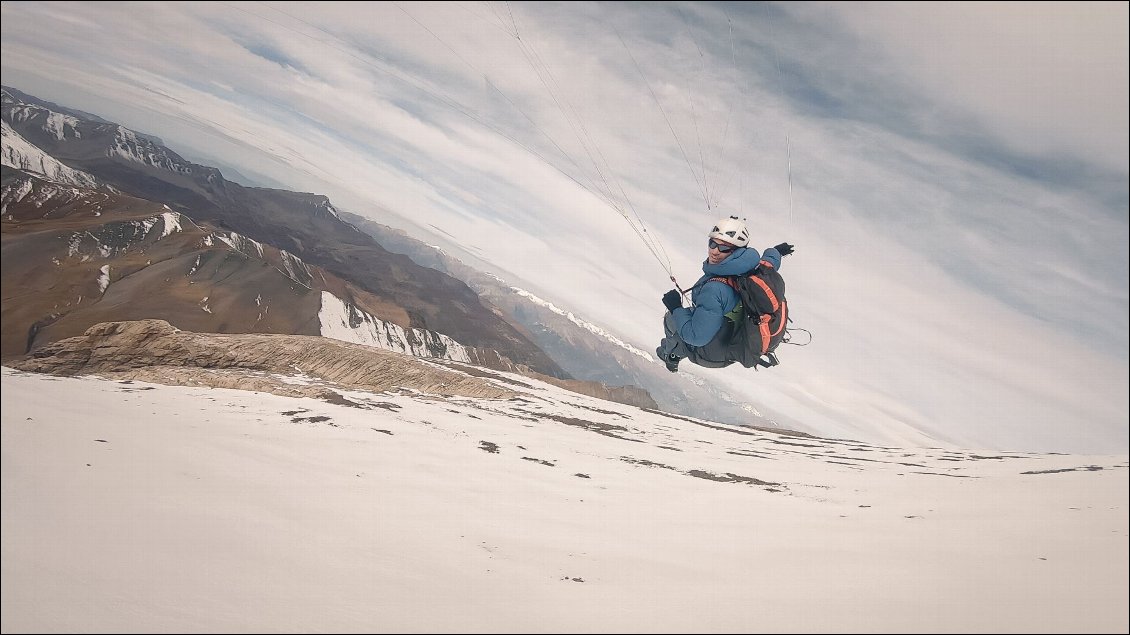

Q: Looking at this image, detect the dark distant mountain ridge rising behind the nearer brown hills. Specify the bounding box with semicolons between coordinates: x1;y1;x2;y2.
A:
3;87;567;379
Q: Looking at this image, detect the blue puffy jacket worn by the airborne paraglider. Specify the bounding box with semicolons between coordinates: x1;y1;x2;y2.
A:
671;247;781;346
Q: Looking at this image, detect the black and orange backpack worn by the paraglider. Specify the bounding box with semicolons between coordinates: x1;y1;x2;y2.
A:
711;255;789;368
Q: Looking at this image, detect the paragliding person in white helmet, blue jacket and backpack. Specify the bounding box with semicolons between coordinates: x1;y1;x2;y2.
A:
655;216;793;373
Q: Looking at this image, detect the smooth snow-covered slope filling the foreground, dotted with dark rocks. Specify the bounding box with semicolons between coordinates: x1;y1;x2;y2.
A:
0;367;1130;633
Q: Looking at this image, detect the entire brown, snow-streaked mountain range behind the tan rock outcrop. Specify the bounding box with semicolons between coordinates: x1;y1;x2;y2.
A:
2;87;654;406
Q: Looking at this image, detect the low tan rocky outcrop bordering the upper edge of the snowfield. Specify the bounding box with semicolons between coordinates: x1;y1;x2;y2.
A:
10;320;655;408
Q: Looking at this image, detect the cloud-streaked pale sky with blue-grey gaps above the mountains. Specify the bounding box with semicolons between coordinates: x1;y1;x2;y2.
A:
0;2;1130;452
